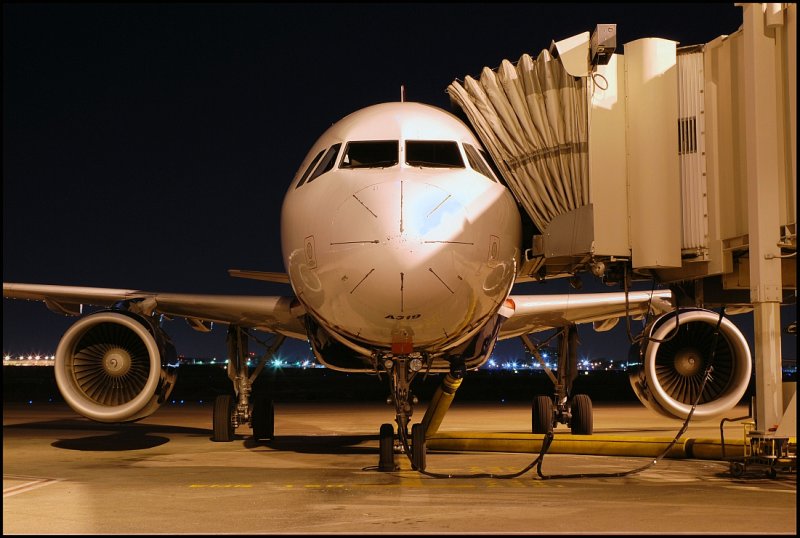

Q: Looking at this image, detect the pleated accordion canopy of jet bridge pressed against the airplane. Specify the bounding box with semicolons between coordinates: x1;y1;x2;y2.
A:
448;50;589;234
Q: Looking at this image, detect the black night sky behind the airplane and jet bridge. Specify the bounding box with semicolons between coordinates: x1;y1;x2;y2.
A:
3;3;795;357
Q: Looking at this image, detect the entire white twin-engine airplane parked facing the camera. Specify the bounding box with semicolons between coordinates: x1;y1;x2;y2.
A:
3;101;751;470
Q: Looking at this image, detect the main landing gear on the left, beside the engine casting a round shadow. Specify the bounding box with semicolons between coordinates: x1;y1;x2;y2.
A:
211;325;286;442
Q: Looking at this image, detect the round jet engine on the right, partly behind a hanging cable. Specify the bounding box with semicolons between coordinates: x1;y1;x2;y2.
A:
630;309;752;419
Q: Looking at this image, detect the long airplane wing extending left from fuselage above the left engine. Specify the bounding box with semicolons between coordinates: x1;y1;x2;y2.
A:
3;282;308;340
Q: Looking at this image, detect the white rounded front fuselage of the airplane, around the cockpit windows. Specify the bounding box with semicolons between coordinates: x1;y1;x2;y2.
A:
281;103;521;366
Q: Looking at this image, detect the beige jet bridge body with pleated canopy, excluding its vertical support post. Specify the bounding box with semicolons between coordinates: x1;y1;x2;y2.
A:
447;5;797;298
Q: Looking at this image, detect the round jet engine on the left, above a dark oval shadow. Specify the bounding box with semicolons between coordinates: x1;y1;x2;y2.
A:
55;311;176;422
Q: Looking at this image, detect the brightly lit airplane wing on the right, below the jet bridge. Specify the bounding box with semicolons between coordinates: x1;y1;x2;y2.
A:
499;290;673;340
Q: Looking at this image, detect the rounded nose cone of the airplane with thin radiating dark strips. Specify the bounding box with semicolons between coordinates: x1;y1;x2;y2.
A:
330;181;475;336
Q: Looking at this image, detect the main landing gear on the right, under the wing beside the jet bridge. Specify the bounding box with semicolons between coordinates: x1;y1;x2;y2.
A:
521;325;594;435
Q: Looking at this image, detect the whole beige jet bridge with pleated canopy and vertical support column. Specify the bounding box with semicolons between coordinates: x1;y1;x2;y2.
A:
447;4;797;426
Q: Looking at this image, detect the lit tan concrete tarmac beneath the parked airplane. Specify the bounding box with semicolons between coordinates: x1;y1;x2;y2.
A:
3;397;797;536
